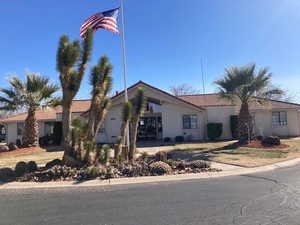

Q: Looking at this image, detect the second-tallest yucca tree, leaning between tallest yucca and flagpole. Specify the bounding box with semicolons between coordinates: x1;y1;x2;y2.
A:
87;56;112;141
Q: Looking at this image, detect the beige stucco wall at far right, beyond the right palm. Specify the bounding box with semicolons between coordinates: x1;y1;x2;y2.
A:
254;110;300;136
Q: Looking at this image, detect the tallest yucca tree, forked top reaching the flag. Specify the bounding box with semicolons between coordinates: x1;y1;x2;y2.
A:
56;30;93;156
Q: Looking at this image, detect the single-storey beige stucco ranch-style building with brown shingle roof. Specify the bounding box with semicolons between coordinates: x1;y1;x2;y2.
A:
2;81;300;143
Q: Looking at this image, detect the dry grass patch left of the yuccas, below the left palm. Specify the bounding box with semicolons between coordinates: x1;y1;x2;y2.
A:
0;149;63;168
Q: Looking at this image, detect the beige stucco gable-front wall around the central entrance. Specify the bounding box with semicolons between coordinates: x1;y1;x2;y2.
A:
96;83;205;143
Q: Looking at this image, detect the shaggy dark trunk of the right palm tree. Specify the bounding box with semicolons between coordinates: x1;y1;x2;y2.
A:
238;103;252;143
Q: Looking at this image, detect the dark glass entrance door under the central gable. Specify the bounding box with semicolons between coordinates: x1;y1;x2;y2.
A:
137;116;162;141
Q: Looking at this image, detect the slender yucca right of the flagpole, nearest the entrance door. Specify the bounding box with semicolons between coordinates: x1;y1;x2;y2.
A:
128;88;146;160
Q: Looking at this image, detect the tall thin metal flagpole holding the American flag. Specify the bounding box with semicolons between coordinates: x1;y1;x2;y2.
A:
121;0;130;146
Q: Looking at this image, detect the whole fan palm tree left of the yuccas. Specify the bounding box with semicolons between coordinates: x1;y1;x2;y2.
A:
0;74;59;146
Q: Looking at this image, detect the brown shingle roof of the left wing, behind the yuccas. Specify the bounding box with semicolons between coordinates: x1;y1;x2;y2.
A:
1;100;91;122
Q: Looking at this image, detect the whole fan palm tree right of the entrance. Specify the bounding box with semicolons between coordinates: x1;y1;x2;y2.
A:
215;64;283;143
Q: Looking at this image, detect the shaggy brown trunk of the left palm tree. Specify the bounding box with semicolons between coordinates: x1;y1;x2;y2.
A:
22;107;39;146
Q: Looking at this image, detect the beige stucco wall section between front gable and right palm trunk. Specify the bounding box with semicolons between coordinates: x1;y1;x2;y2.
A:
206;106;236;140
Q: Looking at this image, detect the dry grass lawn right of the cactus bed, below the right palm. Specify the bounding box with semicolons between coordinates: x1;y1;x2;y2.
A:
141;138;300;167
